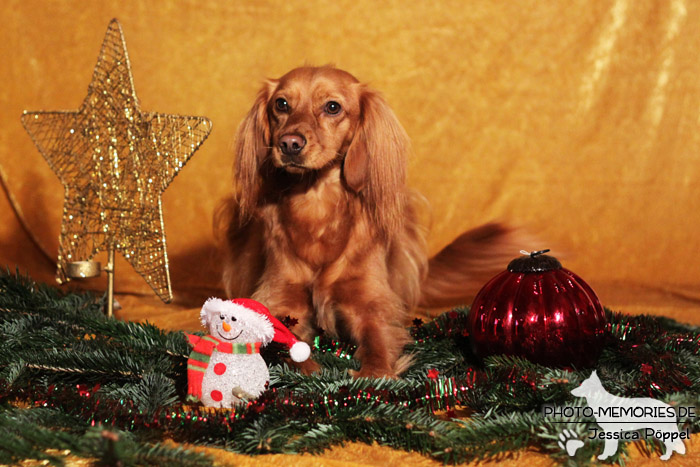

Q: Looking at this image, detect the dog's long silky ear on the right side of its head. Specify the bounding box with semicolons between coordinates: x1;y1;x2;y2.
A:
343;85;410;234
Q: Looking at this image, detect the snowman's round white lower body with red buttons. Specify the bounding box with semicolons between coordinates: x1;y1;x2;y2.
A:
202;350;270;408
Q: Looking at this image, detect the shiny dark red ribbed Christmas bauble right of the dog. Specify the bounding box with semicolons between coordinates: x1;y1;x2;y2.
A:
469;250;605;367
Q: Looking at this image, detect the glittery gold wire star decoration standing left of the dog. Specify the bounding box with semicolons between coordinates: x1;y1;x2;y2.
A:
22;19;211;302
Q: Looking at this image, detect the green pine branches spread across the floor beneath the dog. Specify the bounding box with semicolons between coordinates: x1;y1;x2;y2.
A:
0;271;700;465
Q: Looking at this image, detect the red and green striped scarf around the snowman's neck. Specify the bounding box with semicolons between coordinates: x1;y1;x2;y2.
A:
185;334;260;402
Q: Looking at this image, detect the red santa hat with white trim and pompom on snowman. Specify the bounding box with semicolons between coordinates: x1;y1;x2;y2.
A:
199;298;311;362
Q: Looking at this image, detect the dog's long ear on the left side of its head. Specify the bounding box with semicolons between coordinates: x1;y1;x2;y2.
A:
234;80;277;224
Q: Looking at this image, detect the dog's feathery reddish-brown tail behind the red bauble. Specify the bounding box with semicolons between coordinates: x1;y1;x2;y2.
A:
419;223;530;308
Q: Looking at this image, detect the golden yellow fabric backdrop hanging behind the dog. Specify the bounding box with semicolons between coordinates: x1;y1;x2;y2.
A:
0;0;700;464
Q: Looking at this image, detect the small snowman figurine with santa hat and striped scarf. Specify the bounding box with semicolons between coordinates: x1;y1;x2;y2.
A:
186;298;311;408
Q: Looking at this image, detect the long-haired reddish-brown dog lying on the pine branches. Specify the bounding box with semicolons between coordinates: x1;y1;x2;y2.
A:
217;66;517;377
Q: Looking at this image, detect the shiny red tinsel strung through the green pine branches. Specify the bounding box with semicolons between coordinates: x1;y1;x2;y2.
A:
0;313;694;439
